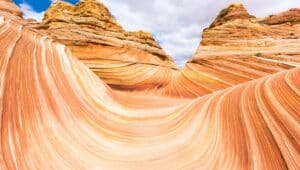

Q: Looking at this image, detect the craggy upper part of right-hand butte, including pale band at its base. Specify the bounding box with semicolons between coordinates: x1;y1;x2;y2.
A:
197;4;300;59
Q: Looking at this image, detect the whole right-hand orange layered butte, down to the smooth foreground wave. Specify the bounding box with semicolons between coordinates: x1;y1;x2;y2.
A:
164;4;300;97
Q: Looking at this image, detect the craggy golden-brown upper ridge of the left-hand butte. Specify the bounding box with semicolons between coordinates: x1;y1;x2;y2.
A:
33;0;175;67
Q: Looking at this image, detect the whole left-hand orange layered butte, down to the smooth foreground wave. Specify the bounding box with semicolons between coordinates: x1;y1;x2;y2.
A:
27;0;178;90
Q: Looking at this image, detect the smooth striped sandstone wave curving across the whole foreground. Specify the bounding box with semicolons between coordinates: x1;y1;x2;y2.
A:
0;1;300;170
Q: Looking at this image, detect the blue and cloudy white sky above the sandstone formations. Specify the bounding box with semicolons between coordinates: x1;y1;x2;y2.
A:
13;0;300;67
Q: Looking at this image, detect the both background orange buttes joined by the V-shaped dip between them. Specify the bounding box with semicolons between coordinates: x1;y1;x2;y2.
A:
26;0;300;98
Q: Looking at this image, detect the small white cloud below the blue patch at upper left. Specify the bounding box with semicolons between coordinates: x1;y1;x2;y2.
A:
20;2;44;21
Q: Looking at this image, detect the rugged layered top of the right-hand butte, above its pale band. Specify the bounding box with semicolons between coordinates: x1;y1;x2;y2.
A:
197;4;300;45
